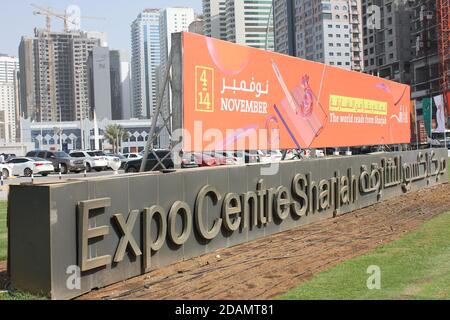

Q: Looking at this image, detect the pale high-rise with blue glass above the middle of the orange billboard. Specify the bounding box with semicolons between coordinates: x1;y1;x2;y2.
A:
273;0;363;71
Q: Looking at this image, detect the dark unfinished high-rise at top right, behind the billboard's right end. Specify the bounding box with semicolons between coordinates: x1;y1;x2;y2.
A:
362;0;450;124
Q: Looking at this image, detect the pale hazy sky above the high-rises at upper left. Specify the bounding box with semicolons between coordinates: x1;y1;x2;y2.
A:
0;0;202;56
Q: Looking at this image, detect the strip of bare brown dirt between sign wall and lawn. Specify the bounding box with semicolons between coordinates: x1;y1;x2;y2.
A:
0;184;450;300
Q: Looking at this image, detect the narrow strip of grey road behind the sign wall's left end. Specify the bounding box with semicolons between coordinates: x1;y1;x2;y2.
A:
0;170;124;201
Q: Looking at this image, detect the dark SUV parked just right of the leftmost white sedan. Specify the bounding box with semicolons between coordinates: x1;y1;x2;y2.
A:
25;150;85;174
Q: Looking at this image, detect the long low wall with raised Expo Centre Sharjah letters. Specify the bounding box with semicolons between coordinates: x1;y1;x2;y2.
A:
8;149;448;299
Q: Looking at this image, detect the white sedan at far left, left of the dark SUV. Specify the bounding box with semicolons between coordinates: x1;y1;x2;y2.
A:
7;157;55;177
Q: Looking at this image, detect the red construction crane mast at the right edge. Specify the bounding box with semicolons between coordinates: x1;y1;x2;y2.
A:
436;0;450;115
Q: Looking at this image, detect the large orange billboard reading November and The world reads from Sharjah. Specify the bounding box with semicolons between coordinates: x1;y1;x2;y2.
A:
182;33;410;151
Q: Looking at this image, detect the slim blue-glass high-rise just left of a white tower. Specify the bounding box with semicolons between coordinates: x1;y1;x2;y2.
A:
131;9;161;118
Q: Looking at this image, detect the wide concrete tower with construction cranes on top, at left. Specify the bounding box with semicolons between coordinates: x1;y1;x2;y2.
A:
19;29;102;121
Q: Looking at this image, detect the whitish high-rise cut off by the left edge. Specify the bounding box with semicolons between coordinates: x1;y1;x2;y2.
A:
0;54;20;143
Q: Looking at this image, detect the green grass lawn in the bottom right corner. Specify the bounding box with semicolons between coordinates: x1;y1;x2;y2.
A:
279;212;450;299
